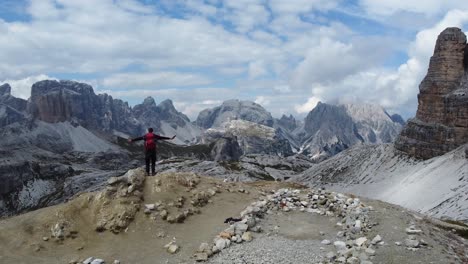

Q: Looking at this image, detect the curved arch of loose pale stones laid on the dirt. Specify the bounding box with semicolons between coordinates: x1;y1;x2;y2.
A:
194;189;384;264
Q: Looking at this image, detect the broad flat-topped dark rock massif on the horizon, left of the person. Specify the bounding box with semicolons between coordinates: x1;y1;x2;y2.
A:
28;80;142;133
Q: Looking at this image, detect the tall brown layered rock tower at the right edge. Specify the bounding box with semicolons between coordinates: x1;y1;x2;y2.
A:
395;28;468;159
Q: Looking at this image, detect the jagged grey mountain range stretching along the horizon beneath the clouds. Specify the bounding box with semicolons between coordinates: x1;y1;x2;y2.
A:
0;80;402;160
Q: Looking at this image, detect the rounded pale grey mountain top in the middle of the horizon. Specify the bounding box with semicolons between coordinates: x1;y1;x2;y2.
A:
195;100;274;129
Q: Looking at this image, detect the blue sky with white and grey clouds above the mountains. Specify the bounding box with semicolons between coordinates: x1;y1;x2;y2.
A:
0;0;468;119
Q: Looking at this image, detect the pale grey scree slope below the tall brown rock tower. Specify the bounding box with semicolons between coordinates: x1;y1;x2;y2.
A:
292;144;468;222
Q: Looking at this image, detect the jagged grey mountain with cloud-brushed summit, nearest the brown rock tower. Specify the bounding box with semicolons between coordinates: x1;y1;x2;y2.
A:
294;102;402;161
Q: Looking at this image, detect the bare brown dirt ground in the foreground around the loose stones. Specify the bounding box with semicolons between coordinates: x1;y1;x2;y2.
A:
0;171;468;264
